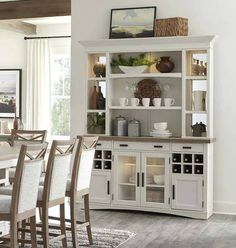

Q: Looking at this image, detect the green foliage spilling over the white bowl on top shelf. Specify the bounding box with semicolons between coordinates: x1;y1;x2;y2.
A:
111;54;157;66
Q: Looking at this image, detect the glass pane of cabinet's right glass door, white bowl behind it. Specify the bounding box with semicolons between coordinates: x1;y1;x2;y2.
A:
145;157;165;203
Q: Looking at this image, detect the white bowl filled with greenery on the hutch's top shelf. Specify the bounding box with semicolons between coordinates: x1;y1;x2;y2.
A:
111;54;156;73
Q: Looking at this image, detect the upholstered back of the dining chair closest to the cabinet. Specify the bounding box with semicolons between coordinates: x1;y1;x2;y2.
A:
71;136;98;194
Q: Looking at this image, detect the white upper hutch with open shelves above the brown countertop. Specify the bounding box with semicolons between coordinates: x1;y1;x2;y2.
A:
80;36;214;137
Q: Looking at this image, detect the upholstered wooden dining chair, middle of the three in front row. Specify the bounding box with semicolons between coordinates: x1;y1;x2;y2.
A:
37;140;75;248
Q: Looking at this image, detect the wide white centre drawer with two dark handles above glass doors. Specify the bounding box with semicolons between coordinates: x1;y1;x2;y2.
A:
114;141;170;151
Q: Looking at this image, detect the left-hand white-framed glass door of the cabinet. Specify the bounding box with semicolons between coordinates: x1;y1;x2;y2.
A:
114;152;140;205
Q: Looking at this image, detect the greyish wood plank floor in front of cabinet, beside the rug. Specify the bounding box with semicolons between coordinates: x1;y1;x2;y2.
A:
82;210;236;248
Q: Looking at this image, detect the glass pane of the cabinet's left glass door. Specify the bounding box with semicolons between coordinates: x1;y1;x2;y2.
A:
118;156;137;201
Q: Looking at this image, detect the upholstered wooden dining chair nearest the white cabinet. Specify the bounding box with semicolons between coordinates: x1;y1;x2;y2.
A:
49;136;98;248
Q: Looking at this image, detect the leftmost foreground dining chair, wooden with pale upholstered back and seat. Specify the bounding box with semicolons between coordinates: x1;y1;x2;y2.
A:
0;143;47;248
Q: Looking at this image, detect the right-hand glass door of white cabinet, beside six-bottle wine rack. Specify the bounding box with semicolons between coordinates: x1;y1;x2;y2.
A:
141;153;169;208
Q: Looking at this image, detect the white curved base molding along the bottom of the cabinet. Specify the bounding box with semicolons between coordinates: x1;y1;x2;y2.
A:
88;203;213;220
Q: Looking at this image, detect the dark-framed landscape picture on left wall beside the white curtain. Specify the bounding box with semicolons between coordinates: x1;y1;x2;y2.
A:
0;69;22;118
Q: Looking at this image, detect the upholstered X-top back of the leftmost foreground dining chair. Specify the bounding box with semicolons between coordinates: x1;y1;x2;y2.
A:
12;143;48;214
